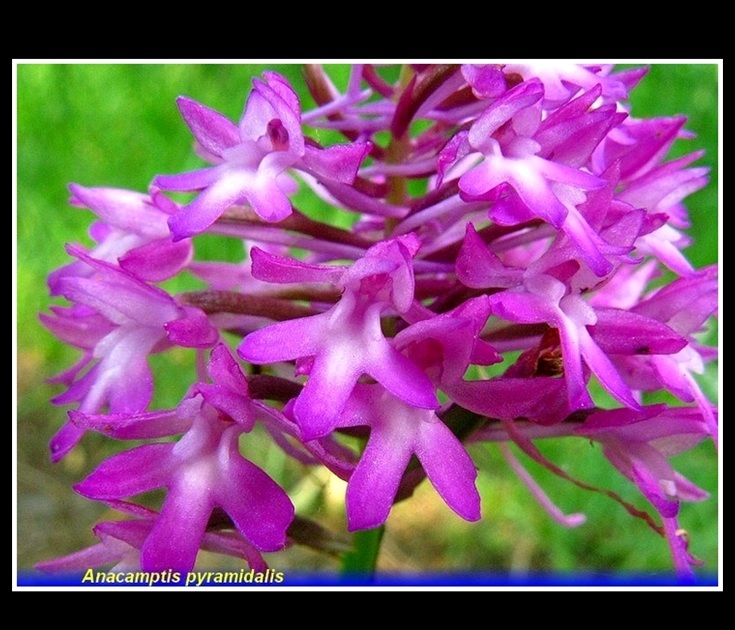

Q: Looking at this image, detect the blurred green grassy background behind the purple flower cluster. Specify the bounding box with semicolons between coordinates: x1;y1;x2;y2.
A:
17;64;718;575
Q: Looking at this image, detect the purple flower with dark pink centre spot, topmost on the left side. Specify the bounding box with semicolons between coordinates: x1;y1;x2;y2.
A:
154;72;369;241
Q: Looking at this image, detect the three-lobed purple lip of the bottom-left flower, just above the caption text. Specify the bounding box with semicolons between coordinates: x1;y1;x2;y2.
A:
75;394;294;571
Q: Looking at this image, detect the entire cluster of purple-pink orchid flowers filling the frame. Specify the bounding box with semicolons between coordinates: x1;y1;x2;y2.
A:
40;63;718;577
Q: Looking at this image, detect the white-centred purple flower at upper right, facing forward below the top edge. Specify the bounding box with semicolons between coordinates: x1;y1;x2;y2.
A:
440;79;618;276
